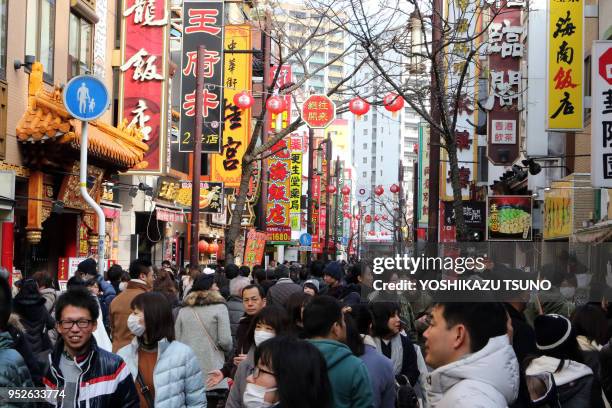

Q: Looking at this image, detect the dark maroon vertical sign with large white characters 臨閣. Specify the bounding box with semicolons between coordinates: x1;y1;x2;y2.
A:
484;7;524;165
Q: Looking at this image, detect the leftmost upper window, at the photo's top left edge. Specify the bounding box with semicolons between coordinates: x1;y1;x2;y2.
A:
25;0;55;82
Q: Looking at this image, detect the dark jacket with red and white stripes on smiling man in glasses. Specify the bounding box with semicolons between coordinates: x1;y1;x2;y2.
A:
43;337;140;408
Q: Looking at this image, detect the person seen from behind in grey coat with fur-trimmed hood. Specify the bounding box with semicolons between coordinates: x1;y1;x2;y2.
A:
174;270;232;407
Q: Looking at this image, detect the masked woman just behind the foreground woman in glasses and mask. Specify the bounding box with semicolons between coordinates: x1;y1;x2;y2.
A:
225;305;289;408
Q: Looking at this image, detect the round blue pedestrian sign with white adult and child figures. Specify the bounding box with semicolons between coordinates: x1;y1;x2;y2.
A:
64;75;109;121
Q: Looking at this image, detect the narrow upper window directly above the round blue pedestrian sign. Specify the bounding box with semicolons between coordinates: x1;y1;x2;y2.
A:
68;13;93;78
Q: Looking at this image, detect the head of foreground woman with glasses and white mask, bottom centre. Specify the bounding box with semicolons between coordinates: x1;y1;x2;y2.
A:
243;336;333;408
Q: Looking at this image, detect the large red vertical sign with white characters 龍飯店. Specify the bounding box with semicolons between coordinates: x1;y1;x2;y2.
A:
119;0;169;174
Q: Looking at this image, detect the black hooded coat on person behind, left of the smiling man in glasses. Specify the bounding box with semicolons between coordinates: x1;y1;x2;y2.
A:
13;286;55;360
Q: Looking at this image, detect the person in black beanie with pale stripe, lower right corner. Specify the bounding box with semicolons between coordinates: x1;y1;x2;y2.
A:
525;314;604;408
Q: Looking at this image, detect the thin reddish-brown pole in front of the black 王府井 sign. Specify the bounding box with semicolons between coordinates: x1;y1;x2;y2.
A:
189;45;205;266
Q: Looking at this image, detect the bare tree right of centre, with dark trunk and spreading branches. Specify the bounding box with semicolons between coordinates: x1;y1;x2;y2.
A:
312;0;501;241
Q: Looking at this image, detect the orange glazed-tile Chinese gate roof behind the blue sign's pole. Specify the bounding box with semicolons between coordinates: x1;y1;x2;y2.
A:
16;63;149;171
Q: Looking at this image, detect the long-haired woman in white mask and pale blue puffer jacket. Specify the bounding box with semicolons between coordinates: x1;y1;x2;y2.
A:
118;292;206;408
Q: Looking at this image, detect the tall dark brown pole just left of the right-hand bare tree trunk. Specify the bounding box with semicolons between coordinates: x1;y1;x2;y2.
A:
423;0;443;244
